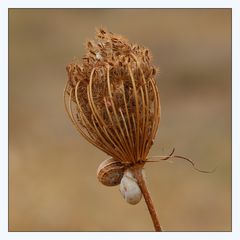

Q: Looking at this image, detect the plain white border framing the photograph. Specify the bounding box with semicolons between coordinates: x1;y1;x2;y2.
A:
0;0;240;240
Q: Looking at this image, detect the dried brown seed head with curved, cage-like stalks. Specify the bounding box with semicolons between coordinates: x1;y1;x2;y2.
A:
64;29;160;166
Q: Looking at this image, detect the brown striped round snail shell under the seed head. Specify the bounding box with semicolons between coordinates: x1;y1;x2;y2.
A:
97;158;124;186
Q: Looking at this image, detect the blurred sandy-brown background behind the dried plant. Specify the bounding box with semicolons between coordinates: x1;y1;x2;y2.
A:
9;9;231;231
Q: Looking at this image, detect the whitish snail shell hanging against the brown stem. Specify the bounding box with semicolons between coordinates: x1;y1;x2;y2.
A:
120;169;142;205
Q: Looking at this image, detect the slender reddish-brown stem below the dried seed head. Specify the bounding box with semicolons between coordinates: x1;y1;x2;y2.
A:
132;167;162;232
